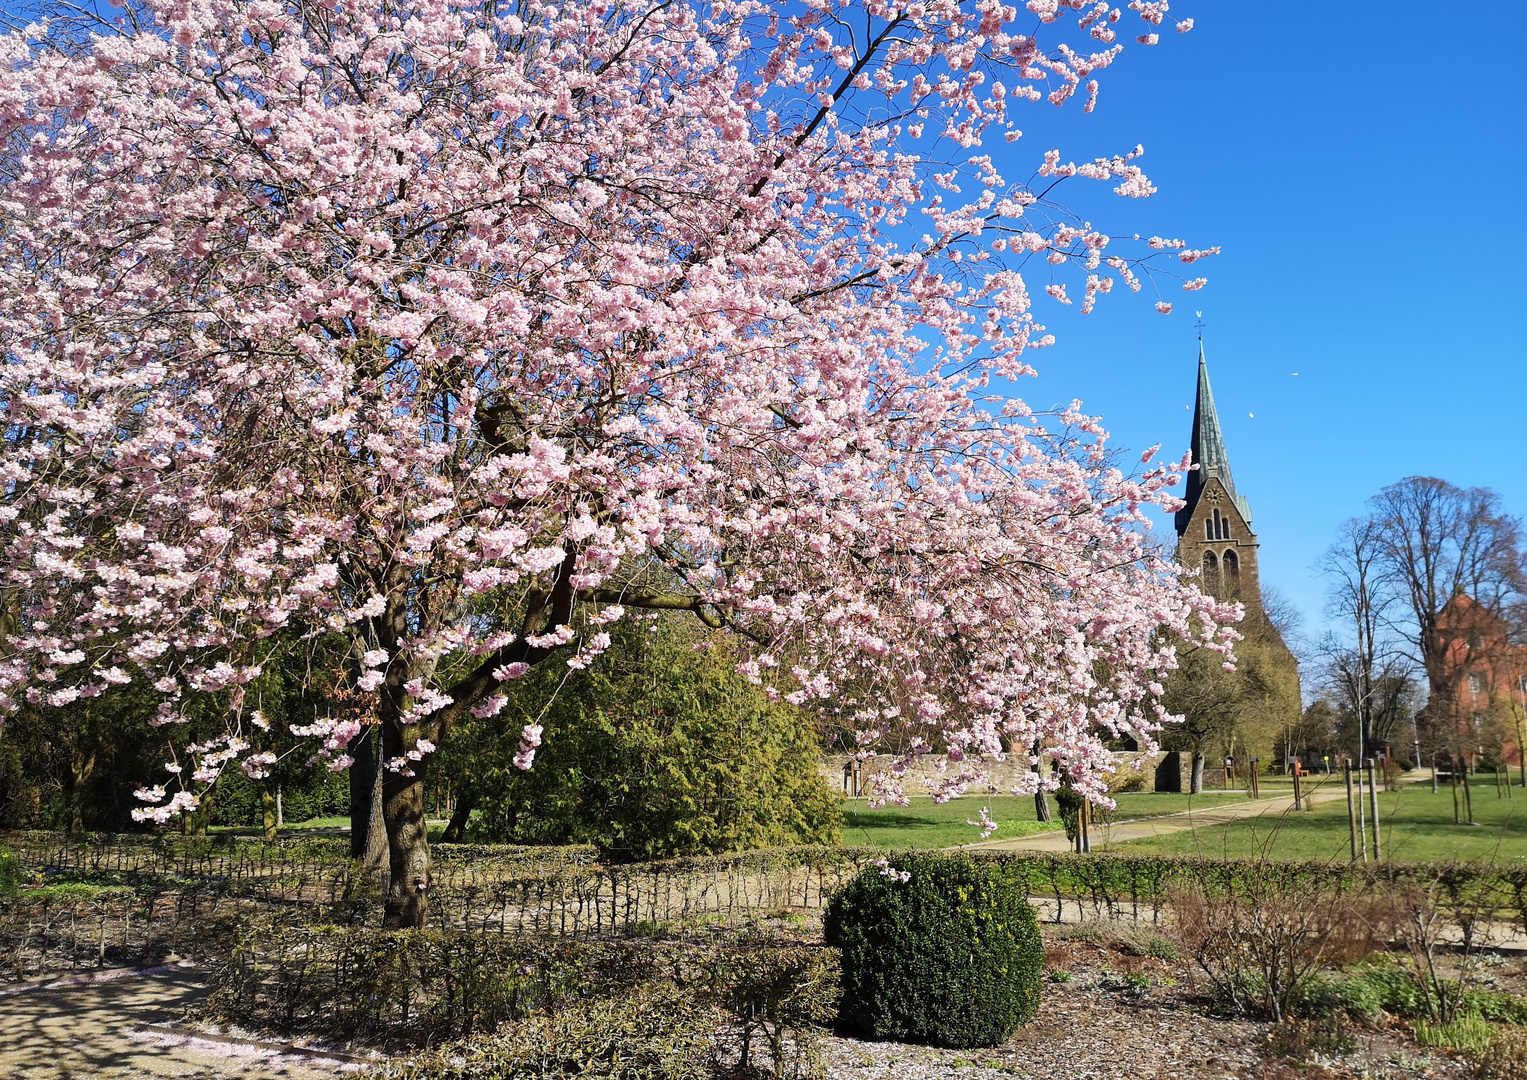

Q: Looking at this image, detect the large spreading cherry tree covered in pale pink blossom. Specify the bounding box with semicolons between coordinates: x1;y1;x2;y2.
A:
0;0;1235;924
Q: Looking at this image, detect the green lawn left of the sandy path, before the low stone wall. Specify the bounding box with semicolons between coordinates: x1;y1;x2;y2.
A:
843;791;1246;848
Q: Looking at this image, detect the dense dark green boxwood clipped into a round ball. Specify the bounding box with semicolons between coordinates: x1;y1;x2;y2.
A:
825;854;1044;1048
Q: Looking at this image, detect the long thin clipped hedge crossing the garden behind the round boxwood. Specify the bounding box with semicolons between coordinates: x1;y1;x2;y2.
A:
17;833;1527;935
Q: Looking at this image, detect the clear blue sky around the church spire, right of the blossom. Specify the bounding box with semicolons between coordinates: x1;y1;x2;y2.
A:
1005;0;1527;650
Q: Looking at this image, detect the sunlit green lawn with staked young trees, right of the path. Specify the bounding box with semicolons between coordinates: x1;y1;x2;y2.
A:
1118;776;1527;862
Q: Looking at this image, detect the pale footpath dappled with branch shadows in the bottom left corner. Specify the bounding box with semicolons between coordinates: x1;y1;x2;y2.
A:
0;968;359;1080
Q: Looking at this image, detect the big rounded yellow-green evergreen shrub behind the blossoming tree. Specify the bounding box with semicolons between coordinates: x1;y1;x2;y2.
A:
441;619;843;860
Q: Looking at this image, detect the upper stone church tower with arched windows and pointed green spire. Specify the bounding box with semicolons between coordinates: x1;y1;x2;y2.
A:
1176;338;1261;613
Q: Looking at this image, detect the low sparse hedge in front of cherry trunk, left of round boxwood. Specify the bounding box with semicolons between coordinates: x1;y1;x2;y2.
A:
205;920;838;1057
